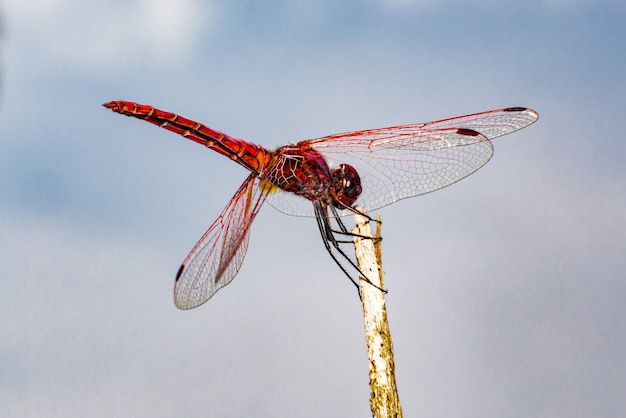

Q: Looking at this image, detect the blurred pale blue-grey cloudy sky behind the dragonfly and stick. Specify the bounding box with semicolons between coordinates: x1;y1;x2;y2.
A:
0;0;626;417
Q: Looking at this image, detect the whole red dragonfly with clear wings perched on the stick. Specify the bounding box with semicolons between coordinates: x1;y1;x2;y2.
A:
103;100;538;309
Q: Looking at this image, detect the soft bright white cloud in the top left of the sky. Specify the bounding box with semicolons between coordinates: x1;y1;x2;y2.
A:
6;0;214;70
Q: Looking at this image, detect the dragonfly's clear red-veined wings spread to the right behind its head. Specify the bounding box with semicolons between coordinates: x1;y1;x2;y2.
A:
269;107;538;216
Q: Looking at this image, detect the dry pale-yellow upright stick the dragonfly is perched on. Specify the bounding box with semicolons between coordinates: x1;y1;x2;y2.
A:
352;208;402;418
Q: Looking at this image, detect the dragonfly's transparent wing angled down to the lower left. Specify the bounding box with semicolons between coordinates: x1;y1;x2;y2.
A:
174;174;269;309
